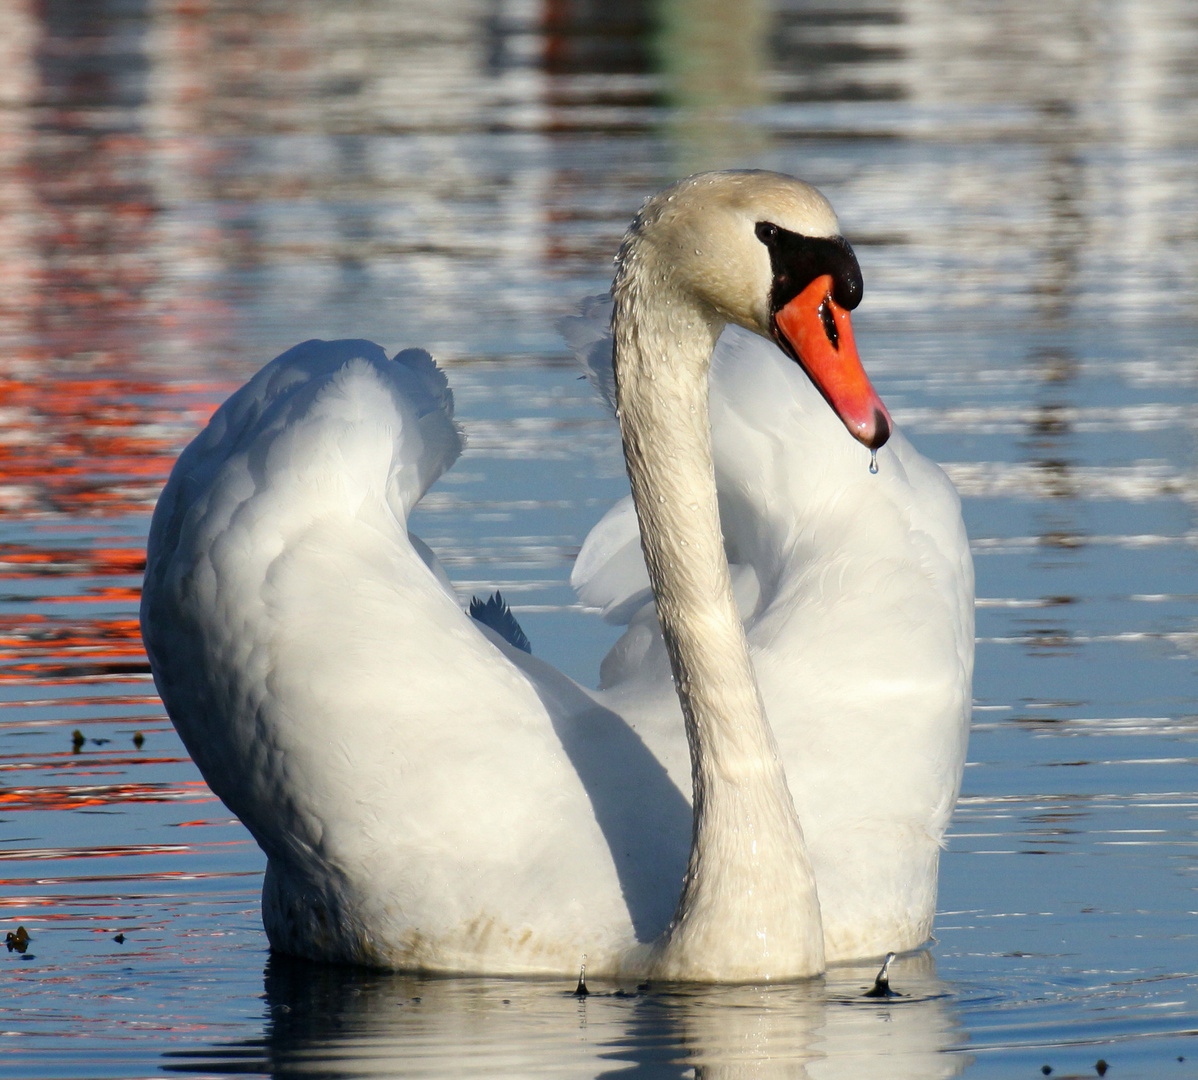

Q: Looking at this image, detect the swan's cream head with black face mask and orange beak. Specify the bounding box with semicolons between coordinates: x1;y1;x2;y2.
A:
616;170;891;450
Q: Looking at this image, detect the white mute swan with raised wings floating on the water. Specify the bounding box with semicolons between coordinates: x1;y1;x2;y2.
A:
141;171;973;982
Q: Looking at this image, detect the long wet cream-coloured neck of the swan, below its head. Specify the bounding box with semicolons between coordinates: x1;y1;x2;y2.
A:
612;249;823;982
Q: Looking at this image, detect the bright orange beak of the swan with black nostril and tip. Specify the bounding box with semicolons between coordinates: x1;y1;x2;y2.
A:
773;274;891;450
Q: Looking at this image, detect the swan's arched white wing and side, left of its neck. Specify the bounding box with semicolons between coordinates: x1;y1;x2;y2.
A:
143;341;688;972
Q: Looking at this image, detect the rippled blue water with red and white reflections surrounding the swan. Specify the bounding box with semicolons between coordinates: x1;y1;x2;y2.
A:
0;0;1198;1080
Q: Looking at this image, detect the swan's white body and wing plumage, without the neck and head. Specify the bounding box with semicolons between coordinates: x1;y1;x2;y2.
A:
143;168;973;979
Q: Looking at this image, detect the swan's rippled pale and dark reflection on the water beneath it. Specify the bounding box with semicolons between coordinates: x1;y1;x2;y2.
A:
162;953;970;1080
